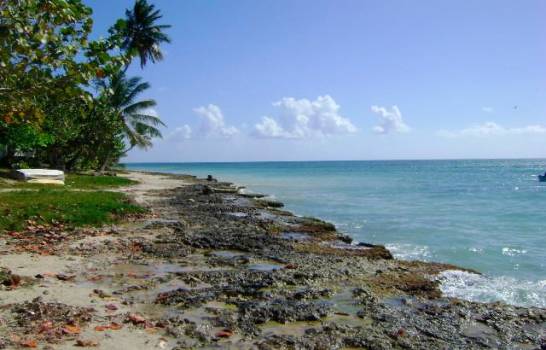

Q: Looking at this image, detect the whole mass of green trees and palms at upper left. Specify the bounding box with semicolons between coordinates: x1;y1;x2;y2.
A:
0;0;169;169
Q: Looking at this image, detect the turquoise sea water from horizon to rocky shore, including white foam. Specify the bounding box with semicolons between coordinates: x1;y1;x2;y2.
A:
127;160;546;307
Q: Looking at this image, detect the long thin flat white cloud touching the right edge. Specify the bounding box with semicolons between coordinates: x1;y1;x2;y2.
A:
438;122;546;138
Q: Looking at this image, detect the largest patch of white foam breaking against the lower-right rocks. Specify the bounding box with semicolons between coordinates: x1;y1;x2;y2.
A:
438;270;546;308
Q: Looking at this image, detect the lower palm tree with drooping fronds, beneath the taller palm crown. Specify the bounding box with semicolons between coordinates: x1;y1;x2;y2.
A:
100;72;165;172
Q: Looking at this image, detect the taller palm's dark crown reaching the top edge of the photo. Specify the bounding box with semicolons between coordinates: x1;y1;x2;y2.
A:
121;0;171;69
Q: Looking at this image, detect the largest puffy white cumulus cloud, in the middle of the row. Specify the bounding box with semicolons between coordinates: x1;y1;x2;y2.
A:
253;95;357;139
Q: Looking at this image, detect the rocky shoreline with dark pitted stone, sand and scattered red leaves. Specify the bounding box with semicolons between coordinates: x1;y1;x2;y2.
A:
0;172;546;349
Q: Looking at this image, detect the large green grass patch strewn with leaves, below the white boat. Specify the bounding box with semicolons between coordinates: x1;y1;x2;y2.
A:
0;188;146;232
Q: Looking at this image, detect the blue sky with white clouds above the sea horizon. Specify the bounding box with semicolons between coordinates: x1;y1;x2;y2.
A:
84;0;546;162
